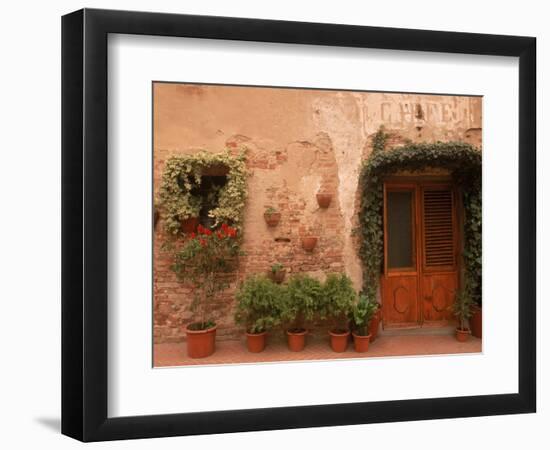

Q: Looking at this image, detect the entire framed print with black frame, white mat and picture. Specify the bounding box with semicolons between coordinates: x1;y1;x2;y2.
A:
62;9;536;441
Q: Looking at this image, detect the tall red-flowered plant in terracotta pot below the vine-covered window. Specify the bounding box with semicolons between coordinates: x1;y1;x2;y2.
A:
171;223;240;358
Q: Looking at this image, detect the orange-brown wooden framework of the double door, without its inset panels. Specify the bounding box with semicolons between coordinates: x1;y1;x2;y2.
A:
380;175;464;329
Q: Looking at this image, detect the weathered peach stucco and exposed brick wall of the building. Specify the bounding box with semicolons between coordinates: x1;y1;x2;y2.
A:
153;83;481;342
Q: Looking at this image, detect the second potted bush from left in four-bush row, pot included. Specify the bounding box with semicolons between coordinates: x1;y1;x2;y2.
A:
281;275;322;352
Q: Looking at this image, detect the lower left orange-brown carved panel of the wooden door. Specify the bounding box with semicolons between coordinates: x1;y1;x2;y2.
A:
382;275;418;325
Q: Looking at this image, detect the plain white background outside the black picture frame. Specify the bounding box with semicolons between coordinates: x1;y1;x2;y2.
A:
0;0;550;449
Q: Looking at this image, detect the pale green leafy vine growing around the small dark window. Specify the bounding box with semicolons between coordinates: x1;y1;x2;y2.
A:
158;150;247;236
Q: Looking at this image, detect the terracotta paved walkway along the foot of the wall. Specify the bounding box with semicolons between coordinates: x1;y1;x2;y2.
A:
154;334;481;367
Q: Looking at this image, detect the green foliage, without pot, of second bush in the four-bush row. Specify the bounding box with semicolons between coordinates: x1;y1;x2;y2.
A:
281;275;323;330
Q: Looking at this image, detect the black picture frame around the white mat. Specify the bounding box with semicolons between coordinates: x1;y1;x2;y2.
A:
62;9;536;441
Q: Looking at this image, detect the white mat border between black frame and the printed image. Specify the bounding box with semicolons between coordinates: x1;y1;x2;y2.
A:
108;35;518;417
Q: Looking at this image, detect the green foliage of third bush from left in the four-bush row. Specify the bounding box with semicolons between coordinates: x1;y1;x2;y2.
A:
319;273;357;331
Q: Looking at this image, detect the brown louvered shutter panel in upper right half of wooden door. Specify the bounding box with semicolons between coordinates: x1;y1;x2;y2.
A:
423;188;455;269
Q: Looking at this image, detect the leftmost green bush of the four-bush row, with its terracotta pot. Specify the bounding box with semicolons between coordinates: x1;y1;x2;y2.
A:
235;276;284;353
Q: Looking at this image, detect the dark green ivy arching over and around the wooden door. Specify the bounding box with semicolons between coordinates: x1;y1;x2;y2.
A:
359;128;481;303
